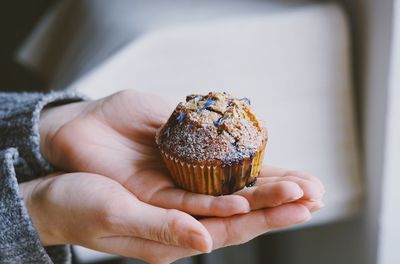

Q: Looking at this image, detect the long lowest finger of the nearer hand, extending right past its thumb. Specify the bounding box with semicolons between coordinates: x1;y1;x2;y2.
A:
200;203;311;249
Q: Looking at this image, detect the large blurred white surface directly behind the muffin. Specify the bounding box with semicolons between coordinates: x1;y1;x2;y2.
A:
72;2;362;224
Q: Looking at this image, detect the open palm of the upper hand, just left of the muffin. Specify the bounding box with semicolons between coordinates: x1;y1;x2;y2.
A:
53;93;172;186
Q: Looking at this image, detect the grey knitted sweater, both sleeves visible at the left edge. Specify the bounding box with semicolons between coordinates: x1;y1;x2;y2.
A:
0;92;87;263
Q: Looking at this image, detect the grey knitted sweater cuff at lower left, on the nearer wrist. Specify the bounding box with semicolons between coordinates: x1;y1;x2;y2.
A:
0;148;70;263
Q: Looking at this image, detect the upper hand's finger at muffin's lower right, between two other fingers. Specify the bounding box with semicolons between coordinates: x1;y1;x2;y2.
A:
235;181;304;210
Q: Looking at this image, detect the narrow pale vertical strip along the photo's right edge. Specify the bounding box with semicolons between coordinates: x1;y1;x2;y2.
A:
378;1;400;264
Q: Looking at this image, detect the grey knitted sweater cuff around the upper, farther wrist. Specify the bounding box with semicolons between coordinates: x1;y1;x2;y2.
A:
0;91;86;182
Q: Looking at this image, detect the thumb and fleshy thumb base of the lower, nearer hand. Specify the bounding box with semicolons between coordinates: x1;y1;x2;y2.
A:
20;173;211;252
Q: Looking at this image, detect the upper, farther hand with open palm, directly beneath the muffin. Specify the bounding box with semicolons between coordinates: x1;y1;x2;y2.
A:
40;91;323;216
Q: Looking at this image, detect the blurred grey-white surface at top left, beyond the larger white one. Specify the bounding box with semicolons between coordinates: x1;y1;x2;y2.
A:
18;0;294;89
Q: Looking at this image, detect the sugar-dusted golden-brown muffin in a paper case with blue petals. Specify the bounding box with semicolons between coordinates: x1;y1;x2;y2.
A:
156;92;267;195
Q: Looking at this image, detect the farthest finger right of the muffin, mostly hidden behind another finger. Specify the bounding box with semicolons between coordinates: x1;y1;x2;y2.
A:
256;176;323;200
